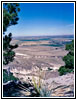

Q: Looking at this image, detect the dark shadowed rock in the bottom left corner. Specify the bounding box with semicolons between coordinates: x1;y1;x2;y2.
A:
3;81;39;97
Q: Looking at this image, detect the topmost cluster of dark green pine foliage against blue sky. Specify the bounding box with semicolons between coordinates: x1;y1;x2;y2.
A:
3;3;20;32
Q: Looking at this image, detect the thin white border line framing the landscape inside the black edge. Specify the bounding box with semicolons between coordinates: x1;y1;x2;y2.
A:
0;0;76;100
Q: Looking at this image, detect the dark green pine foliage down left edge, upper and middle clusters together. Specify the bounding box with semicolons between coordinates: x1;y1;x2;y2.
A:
3;3;20;65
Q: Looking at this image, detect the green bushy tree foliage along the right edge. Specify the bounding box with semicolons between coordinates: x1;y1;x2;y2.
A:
58;40;74;75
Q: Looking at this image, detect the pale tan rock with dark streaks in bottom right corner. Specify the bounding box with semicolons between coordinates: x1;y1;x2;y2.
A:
51;85;74;97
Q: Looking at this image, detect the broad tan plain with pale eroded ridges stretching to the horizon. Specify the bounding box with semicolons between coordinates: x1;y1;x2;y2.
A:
4;37;71;81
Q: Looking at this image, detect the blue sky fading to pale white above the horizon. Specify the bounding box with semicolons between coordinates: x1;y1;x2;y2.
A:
6;3;74;36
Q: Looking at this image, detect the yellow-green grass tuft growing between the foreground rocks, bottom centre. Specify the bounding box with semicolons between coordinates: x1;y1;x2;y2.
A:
32;69;51;97
